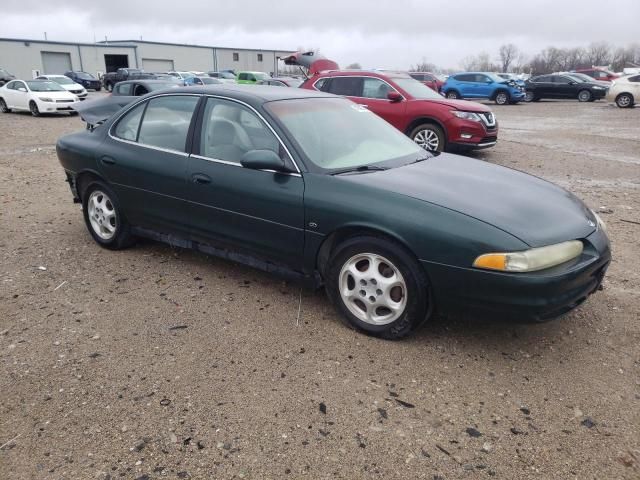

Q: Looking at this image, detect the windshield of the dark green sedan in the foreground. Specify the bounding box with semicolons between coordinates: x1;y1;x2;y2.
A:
266;98;427;173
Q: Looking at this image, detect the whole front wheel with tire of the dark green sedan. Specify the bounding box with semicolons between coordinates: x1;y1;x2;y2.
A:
326;236;432;340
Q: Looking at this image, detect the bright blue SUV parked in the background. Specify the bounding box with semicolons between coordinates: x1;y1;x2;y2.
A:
441;72;525;105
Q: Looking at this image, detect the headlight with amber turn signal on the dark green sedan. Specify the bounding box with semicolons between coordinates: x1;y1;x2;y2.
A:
473;240;584;272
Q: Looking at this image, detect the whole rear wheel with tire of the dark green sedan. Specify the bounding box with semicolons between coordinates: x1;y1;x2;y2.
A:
82;182;133;250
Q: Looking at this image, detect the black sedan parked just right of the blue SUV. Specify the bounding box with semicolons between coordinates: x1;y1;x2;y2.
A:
525;75;607;102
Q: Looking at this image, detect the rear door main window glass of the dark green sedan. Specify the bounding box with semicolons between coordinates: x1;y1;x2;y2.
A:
138;95;198;152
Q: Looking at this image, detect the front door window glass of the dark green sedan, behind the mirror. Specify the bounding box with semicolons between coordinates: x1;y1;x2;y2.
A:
200;98;286;163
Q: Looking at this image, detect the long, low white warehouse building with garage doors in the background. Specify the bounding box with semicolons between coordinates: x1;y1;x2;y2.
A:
0;38;293;78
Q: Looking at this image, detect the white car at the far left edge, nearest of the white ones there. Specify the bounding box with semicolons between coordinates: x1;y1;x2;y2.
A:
0;80;80;117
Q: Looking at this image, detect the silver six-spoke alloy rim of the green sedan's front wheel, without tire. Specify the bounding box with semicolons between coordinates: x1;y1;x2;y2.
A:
339;253;407;325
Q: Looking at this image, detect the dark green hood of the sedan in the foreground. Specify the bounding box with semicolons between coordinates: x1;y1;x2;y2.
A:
339;154;595;247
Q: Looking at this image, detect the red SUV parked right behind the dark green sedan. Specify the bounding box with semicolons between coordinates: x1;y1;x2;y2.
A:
301;70;498;151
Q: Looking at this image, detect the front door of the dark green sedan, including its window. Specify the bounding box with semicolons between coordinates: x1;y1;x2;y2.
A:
188;97;304;270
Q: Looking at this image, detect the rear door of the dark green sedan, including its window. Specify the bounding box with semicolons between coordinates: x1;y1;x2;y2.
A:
97;95;200;236
